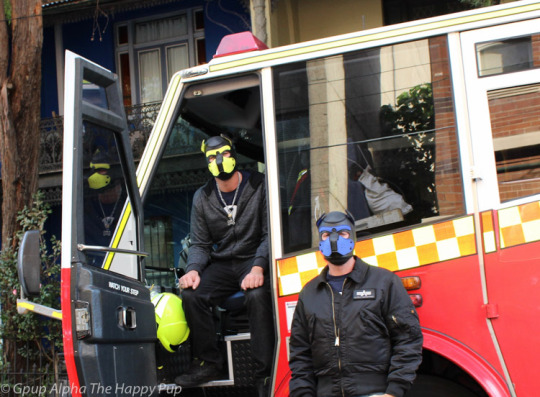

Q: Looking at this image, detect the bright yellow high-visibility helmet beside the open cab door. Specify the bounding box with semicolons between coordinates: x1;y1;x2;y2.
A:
152;292;189;353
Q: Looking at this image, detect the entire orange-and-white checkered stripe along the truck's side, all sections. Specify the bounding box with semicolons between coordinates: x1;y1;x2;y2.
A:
278;201;540;296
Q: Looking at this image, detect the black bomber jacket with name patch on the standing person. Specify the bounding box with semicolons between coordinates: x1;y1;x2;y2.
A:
289;257;423;397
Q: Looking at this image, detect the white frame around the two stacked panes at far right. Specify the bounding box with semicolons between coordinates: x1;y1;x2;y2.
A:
458;19;540;212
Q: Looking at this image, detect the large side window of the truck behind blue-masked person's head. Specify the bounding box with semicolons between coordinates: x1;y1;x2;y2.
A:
274;37;464;253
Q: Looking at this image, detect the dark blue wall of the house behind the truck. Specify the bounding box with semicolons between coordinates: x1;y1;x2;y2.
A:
41;0;251;118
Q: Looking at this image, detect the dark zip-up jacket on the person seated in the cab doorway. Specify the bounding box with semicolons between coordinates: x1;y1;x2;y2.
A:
186;171;268;274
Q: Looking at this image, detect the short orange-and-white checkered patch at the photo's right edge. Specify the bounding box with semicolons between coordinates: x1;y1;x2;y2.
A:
499;201;540;248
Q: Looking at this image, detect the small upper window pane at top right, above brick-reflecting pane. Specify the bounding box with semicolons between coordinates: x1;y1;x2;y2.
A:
476;35;540;76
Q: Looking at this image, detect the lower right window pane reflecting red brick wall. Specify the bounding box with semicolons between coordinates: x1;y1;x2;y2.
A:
488;84;540;202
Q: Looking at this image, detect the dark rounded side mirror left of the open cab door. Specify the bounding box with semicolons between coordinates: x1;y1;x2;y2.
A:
17;230;41;296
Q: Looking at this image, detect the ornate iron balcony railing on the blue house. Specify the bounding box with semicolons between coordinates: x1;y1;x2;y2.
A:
39;102;161;173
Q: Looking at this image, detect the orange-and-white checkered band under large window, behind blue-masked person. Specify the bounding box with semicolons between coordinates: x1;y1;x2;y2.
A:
278;216;476;296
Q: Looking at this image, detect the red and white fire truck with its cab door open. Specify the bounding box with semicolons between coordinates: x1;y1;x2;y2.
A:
14;1;540;397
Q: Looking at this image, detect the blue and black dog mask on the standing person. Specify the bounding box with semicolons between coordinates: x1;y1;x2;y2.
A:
317;211;356;266
